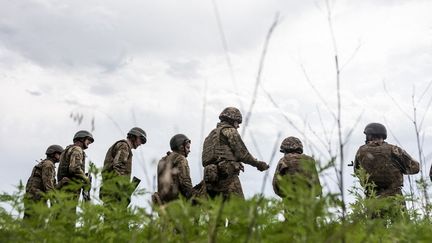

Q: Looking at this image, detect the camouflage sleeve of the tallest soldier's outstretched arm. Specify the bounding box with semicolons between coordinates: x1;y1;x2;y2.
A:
222;128;258;166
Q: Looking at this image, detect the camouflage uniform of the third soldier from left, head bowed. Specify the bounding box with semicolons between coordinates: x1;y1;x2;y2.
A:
100;139;133;204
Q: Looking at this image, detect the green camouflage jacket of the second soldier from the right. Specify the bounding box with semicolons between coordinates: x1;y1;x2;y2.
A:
273;153;321;197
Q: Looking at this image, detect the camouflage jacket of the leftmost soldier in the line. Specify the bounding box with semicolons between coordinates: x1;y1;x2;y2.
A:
26;158;56;200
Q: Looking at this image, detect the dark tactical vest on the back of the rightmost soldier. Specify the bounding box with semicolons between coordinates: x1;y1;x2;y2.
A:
359;144;403;190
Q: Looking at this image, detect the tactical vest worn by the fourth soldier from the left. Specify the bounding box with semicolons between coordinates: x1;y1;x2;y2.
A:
157;152;180;203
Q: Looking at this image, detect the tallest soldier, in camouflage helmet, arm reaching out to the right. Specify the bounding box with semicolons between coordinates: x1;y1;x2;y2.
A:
202;107;269;199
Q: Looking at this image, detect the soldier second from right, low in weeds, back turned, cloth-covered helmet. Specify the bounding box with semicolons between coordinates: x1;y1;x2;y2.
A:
273;137;321;197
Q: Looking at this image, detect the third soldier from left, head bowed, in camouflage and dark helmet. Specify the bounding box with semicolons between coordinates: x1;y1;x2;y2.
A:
100;127;147;207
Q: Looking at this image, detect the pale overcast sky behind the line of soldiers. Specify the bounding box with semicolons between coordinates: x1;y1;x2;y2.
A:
0;0;432;209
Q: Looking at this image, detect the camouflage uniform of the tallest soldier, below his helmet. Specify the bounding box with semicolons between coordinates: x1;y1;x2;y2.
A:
203;121;266;198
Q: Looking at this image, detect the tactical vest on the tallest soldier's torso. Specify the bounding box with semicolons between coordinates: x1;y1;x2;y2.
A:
202;125;236;166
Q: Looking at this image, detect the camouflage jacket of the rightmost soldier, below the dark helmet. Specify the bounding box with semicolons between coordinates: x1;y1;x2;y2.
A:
354;140;420;196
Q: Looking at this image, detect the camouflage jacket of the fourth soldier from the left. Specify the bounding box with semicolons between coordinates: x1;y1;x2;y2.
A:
157;152;194;203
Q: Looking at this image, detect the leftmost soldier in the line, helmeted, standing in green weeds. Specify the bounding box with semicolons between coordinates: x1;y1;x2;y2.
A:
24;145;63;218
